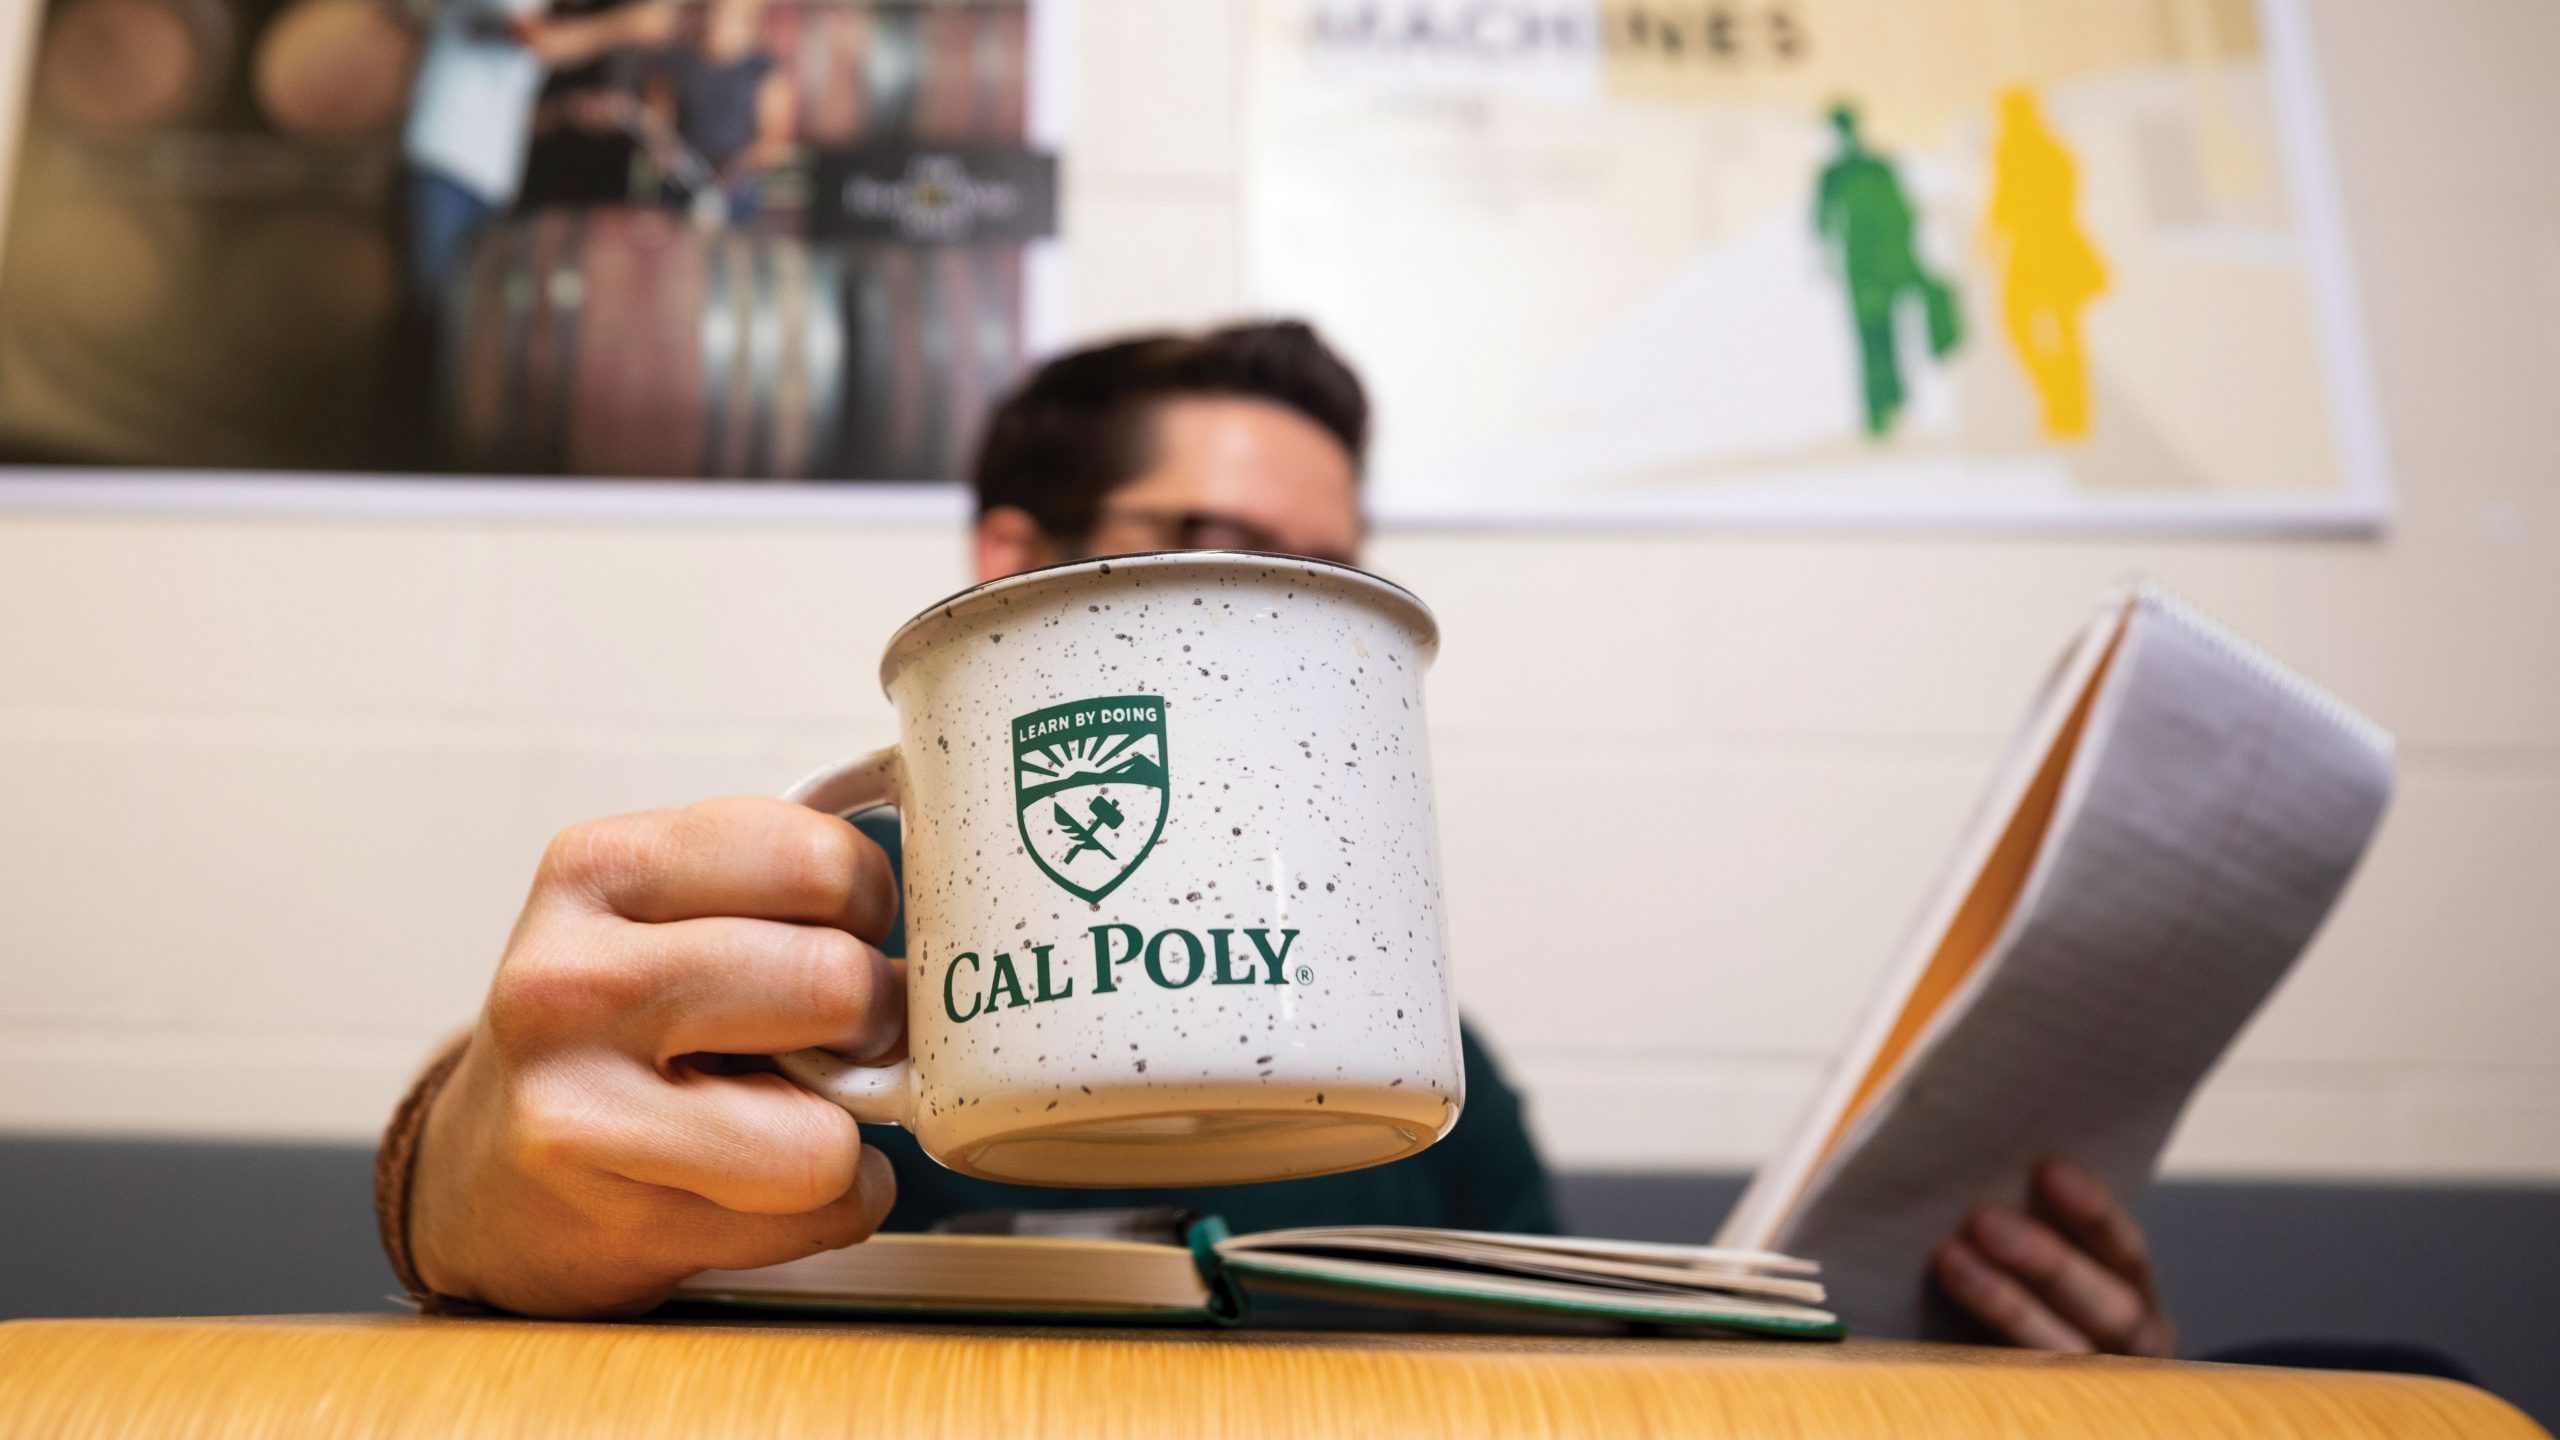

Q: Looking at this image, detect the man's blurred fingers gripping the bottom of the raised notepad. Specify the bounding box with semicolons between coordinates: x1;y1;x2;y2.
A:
1933;1161;2179;1355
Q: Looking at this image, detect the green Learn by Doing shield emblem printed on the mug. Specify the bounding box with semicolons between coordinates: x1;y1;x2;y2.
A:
1014;694;1167;902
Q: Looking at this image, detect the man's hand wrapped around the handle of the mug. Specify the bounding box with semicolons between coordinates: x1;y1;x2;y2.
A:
410;799;906;1314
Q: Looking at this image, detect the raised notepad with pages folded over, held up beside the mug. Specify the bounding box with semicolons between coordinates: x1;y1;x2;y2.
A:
1718;587;2394;1335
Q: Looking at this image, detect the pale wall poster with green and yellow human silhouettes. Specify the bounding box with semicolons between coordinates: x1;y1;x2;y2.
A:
1244;0;2388;530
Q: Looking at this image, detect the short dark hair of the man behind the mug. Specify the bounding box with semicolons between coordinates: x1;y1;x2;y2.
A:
970;320;1370;538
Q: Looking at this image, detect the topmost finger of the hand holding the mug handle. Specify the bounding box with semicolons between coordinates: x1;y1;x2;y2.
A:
543;797;899;943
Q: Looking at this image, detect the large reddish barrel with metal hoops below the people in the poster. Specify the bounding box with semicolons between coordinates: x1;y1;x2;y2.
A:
445;208;845;479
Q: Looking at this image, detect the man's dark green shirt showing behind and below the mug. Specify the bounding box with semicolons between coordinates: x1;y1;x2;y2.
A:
855;812;1556;1235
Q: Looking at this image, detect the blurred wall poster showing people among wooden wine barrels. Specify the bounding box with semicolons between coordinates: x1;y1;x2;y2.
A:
0;0;1070;510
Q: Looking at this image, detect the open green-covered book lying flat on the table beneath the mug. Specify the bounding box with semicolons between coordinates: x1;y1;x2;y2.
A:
676;1209;1841;1340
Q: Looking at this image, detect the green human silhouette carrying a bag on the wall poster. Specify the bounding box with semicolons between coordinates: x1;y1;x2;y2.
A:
1812;105;1961;436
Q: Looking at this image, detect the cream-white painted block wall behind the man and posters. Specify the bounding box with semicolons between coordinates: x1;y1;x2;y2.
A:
0;0;2560;1181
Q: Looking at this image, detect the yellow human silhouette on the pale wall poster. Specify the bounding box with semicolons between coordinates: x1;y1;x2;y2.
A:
1981;87;2107;441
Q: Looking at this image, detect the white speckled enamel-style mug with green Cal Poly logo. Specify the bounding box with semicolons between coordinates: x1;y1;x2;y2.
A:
781;551;1464;1186
